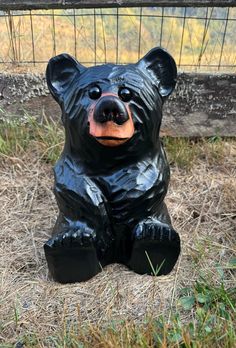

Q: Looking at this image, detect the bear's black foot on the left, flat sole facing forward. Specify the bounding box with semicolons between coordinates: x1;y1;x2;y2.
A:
44;228;101;283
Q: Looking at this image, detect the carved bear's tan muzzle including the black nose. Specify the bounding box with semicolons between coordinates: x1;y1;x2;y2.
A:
88;94;134;146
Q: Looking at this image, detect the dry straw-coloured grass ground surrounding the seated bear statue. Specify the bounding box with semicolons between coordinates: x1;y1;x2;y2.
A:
0;142;236;343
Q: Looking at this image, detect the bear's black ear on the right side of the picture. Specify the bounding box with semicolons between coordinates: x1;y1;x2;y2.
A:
137;47;177;97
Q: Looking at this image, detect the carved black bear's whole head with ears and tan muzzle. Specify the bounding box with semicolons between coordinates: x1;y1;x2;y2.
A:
46;47;177;169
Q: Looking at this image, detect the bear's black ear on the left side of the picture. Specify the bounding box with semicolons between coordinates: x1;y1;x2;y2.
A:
46;53;86;102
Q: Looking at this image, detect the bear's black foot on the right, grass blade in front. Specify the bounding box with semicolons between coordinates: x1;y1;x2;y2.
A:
128;219;180;276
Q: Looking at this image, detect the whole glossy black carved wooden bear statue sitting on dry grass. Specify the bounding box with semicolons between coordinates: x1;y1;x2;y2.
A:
44;47;180;283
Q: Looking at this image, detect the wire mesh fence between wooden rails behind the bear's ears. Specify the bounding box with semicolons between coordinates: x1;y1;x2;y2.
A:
0;7;236;72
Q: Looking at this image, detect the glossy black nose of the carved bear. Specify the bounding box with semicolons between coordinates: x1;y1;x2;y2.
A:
94;95;129;125
